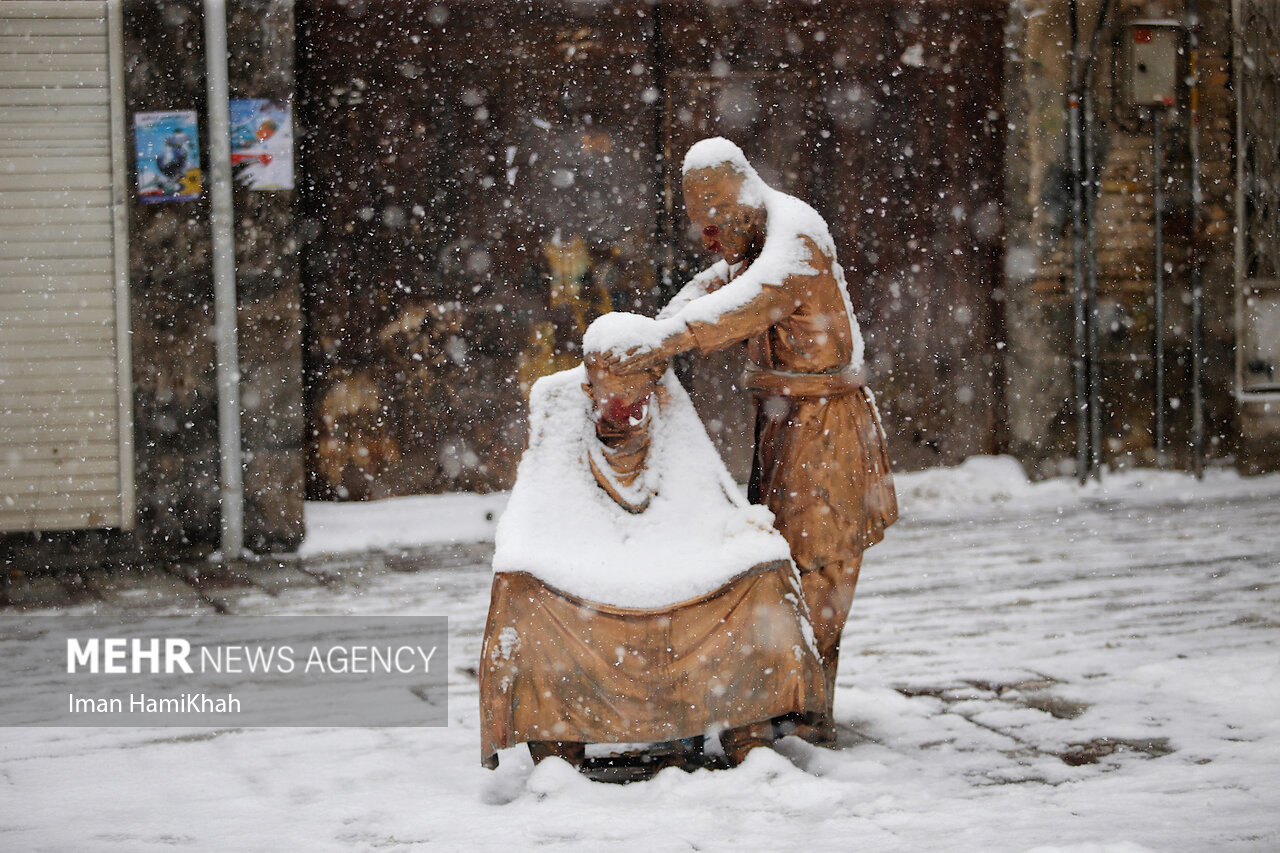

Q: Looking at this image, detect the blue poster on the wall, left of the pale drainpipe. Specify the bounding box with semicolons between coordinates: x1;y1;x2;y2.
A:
133;110;204;204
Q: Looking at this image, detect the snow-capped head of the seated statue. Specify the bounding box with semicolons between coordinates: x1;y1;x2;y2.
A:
582;311;667;429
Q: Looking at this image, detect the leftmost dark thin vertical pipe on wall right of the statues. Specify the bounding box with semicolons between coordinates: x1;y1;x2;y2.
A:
1066;0;1089;484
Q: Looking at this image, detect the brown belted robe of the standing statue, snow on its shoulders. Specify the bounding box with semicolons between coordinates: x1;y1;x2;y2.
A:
659;188;897;571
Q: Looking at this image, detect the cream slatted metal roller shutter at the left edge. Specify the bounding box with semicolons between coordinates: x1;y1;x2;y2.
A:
0;0;133;532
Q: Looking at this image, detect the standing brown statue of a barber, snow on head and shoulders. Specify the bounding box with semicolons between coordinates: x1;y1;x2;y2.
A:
608;138;897;742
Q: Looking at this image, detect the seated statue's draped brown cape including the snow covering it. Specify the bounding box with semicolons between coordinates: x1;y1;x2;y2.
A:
480;368;826;767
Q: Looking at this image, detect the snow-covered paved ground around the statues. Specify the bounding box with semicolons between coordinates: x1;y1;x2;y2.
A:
0;459;1280;853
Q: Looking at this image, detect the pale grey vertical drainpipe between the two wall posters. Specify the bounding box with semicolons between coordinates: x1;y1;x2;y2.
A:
205;0;244;561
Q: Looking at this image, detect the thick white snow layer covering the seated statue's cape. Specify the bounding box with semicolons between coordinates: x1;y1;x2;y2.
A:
493;366;790;608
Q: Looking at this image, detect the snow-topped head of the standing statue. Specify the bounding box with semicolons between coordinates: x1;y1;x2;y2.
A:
682;137;768;264
